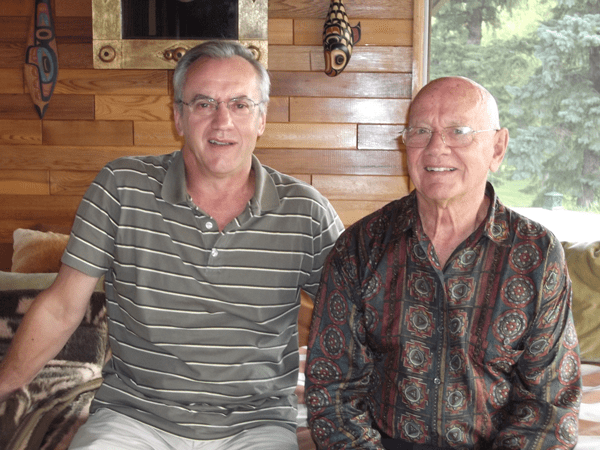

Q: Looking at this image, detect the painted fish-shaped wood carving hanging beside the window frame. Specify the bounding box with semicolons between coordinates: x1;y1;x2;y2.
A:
323;0;360;77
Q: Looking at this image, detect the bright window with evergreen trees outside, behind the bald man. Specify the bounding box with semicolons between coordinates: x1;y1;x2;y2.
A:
429;0;600;241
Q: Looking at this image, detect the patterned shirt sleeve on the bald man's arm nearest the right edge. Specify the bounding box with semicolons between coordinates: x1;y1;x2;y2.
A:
493;238;581;450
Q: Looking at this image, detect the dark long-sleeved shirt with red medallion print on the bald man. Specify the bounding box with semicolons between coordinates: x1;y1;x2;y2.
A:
306;184;581;450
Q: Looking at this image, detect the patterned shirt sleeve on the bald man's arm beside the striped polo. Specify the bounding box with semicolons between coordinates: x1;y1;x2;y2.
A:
305;234;383;450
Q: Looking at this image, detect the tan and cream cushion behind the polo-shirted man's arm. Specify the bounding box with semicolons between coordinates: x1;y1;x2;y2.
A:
10;228;69;273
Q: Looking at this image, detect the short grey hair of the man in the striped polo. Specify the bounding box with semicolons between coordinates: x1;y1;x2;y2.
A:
173;41;271;113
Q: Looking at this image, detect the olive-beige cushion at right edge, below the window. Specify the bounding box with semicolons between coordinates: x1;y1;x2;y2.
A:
563;241;600;362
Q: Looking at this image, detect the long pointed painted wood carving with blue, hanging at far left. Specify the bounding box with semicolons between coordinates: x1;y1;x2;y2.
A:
23;0;58;119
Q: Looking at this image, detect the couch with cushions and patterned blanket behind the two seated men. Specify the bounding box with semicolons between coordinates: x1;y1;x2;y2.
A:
0;229;600;450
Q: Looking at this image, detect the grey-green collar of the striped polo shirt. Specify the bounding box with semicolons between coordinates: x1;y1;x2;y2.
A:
161;151;280;215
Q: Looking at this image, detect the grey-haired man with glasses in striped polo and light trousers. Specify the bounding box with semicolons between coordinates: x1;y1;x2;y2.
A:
0;42;343;450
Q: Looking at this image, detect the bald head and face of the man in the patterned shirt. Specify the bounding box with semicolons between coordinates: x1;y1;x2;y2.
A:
406;77;509;211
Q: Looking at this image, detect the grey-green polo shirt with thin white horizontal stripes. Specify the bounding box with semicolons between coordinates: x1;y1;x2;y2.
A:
62;151;343;440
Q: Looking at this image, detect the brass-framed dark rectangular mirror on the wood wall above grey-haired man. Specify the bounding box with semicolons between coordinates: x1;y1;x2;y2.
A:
92;0;269;69
